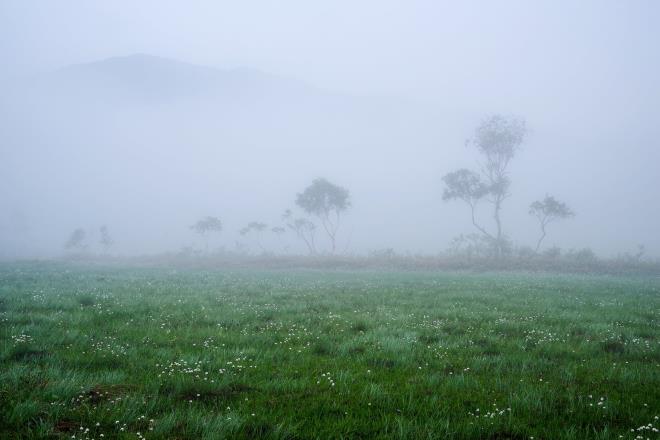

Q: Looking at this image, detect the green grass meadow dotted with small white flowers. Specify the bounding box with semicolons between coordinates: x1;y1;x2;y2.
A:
0;263;660;440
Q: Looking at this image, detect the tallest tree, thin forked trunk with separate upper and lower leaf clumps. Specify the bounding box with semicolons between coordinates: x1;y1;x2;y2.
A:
443;115;527;256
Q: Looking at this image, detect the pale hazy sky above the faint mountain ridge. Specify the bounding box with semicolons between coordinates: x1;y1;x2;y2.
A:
0;0;660;103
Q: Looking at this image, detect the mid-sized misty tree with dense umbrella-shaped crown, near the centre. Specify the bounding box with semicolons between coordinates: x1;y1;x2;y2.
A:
296;178;351;253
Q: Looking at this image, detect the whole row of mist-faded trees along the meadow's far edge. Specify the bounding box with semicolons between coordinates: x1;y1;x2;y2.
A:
65;115;575;257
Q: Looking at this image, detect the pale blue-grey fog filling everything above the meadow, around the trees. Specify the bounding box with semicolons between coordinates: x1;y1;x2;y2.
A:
0;0;660;259
